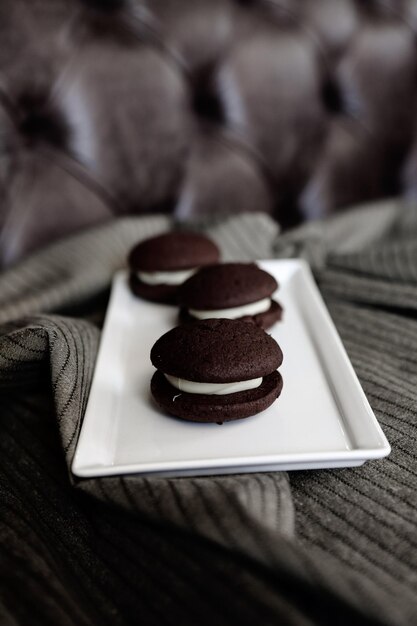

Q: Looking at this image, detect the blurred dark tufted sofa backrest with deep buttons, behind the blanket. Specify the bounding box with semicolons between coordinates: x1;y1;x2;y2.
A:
0;0;417;266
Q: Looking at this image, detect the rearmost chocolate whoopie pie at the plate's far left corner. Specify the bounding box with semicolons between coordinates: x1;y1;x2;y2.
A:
128;232;220;303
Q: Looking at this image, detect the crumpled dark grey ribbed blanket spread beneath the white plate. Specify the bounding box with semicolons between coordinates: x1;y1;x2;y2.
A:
0;201;417;626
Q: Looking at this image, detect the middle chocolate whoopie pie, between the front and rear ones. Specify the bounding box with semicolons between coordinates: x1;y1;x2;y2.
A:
178;263;282;329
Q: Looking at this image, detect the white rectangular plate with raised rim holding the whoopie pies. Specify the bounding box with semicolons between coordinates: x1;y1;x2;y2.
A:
72;260;390;477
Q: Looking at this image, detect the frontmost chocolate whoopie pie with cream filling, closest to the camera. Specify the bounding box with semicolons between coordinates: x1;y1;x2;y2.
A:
151;319;282;424
